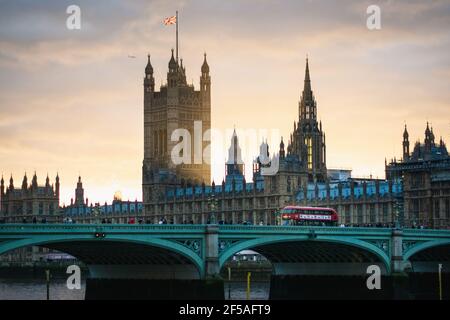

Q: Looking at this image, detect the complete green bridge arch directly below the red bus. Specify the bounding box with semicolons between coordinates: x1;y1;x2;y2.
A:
219;236;391;274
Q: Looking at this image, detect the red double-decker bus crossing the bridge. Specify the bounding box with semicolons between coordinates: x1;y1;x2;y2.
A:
280;206;338;226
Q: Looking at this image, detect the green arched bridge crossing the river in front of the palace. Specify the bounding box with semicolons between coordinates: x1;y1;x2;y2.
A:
0;224;450;298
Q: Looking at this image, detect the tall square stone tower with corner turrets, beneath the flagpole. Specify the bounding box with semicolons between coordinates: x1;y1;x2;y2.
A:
142;50;211;203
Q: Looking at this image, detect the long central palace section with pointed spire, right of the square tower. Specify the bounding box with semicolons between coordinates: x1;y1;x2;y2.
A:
144;60;408;225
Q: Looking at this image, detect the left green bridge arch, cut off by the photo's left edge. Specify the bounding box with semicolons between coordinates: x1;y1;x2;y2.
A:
0;234;205;278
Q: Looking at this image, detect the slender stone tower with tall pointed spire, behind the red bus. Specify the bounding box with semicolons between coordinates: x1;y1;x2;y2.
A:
288;59;327;182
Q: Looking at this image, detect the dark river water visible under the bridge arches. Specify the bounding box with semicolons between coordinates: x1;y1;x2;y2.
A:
0;278;270;300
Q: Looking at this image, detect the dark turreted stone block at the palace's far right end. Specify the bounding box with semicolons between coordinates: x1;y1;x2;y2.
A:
386;123;450;228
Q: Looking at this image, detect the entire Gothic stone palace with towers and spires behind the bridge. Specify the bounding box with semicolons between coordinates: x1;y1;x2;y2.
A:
0;51;450;228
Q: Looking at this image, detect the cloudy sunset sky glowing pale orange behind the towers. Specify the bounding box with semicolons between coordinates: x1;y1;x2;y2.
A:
0;0;450;204
